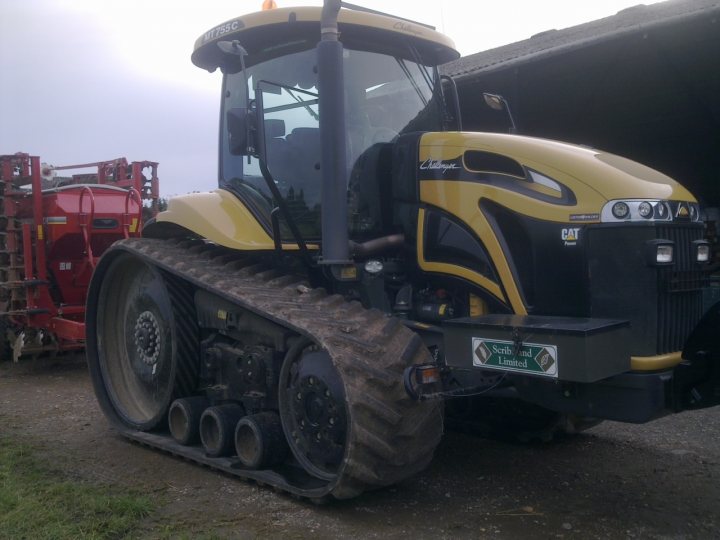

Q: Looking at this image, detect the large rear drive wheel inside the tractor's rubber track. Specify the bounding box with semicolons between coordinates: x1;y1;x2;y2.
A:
87;252;197;431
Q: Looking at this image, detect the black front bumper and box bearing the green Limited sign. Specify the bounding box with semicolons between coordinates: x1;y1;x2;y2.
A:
428;314;720;423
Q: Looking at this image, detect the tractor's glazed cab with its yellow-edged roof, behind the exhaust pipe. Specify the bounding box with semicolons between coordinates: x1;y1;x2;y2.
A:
193;4;457;241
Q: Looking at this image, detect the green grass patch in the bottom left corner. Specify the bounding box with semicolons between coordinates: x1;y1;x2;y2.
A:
0;434;154;539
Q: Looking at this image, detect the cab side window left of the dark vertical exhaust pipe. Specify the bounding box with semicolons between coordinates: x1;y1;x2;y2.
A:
220;48;321;241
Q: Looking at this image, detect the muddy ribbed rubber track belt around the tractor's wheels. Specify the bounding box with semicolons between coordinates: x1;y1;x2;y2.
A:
95;238;443;501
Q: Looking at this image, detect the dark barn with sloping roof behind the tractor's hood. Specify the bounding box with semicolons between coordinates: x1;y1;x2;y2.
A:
444;0;720;209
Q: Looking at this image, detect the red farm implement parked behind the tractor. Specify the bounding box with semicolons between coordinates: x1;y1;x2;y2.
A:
0;153;158;360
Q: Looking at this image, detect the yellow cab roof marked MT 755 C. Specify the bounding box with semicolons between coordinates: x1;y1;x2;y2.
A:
191;7;460;71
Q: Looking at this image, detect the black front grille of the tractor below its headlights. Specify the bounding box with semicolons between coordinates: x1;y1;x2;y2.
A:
656;224;708;354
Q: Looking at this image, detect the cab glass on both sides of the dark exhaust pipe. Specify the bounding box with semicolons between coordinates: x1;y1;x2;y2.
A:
220;45;442;239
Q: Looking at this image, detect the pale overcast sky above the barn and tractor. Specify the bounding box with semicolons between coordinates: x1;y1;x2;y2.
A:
0;0;653;196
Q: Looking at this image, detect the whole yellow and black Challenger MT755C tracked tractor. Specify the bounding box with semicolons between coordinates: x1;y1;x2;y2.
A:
87;0;720;499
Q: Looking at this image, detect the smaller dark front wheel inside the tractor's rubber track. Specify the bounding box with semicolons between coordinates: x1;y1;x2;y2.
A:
279;340;348;481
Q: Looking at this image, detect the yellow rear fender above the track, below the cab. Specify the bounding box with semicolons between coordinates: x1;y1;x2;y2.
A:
157;189;317;251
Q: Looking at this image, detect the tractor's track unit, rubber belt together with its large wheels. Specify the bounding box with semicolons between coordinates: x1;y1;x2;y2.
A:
87;239;443;500
